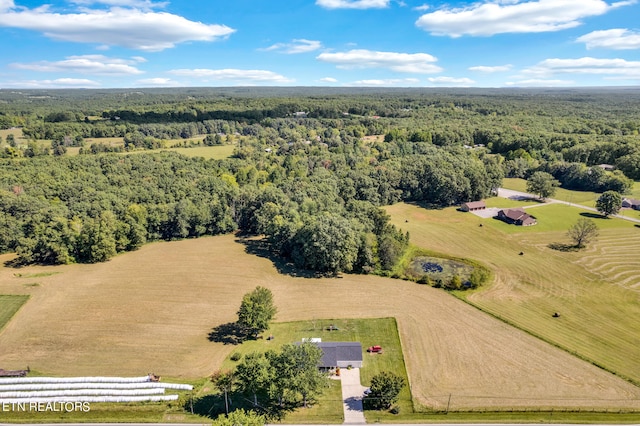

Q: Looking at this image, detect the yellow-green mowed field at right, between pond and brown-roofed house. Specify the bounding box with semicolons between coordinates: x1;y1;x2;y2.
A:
386;204;640;392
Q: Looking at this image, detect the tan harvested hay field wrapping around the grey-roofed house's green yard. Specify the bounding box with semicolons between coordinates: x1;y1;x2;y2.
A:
0;235;640;409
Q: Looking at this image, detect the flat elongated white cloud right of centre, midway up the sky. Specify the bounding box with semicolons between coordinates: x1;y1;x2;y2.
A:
316;49;442;74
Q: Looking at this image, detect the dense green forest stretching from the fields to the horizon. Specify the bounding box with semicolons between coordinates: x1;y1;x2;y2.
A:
0;88;640;273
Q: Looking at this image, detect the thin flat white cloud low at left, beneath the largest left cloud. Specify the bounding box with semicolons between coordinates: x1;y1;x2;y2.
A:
10;55;146;75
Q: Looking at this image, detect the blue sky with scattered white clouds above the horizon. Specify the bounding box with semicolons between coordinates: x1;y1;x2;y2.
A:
0;0;640;89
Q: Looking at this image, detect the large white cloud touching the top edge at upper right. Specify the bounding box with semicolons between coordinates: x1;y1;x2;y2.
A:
416;0;634;37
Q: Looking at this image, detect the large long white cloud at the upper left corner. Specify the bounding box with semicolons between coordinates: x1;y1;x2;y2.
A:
0;0;235;52
